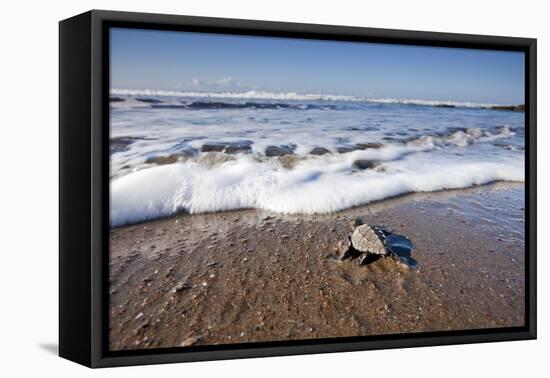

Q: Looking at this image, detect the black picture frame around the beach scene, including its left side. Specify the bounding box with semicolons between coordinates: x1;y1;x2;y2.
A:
59;10;537;367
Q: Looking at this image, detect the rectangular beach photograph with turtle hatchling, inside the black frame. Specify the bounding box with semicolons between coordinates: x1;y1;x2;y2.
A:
108;28;526;351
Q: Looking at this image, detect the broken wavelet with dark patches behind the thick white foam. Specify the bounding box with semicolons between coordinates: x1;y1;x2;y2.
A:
110;126;516;177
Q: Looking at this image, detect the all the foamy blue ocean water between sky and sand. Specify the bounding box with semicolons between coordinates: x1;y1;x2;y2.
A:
110;90;525;227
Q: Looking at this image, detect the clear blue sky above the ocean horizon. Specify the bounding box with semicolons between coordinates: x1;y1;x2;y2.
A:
111;28;524;104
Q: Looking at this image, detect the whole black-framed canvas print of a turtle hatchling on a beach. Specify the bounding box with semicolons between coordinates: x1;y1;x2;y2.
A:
59;11;536;367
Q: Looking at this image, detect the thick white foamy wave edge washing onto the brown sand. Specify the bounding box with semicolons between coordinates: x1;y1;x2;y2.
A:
110;151;524;227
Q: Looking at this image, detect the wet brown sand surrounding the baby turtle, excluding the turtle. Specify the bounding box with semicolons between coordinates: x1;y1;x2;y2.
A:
110;183;525;350
